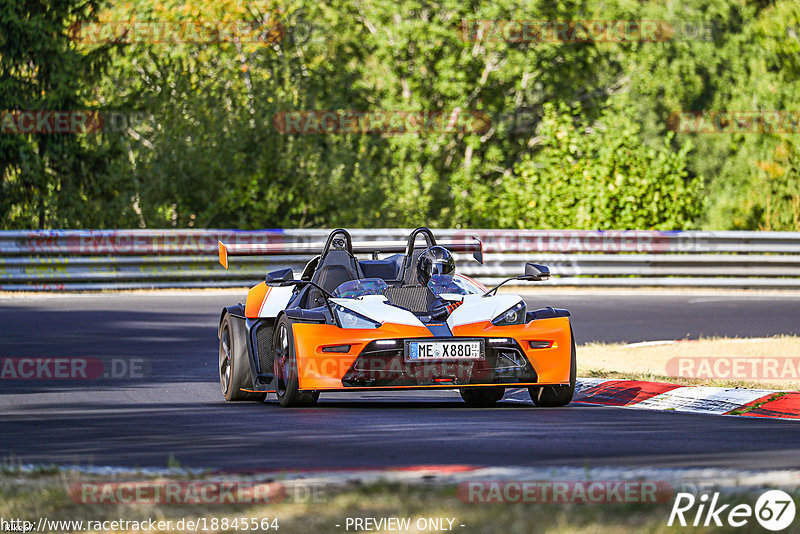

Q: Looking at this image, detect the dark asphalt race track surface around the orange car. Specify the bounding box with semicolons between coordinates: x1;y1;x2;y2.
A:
0;292;800;469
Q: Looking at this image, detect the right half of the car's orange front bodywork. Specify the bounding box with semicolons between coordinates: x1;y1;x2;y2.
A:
453;317;572;384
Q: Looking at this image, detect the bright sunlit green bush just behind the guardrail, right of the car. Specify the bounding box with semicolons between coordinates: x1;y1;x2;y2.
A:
491;105;702;230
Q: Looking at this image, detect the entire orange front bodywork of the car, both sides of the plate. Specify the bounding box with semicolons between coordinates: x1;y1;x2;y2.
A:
290;316;572;390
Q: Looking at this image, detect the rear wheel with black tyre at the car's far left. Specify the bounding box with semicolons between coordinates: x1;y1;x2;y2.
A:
219;313;267;402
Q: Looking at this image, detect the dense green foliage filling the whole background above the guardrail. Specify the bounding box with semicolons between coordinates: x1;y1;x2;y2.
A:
0;0;800;230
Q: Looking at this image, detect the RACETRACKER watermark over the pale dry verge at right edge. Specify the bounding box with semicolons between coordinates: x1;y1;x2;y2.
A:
666;356;800;380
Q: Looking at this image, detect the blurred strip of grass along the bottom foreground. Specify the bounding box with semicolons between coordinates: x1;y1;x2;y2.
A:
0;472;788;534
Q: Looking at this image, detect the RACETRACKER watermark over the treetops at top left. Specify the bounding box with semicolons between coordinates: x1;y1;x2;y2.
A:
70;18;286;44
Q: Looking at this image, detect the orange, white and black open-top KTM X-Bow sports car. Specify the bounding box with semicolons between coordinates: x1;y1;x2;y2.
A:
214;228;576;406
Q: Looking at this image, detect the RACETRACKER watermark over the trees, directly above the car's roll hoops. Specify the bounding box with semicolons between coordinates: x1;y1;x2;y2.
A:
272;109;492;135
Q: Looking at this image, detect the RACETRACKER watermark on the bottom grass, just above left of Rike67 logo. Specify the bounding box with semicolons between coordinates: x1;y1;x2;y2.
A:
457;480;674;504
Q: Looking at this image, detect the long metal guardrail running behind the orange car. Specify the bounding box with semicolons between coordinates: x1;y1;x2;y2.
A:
0;229;800;291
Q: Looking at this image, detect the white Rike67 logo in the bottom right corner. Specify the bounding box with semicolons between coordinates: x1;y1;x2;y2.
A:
667;490;795;532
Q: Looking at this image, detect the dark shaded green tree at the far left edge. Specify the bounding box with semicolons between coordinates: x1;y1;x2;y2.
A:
0;0;125;228
